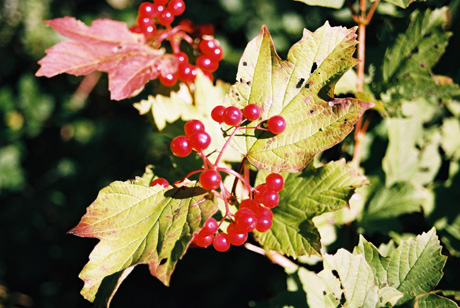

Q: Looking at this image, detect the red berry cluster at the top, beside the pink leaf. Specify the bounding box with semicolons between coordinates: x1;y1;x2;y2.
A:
130;0;224;87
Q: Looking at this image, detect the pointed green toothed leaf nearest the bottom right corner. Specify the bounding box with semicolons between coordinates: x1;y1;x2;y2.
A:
388;228;447;304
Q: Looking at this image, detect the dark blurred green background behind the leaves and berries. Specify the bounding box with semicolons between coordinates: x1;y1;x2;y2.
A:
0;0;460;308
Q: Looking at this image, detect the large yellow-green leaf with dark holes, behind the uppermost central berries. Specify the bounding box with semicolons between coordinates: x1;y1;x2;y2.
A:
224;23;373;172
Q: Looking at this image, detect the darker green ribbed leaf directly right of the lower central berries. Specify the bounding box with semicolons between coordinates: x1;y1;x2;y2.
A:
255;160;367;258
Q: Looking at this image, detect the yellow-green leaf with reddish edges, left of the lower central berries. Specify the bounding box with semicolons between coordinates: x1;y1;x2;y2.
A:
69;182;216;302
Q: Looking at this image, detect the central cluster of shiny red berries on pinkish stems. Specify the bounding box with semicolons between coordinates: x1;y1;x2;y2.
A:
152;104;286;251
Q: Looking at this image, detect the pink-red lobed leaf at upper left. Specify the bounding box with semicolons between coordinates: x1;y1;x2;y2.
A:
35;17;172;100
